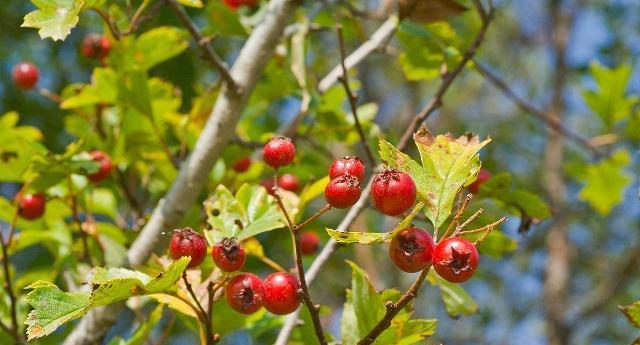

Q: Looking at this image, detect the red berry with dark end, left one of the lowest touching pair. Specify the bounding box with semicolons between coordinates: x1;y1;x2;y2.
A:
224;273;265;314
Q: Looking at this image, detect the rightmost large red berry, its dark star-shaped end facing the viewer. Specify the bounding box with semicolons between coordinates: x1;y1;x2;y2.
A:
433;237;480;283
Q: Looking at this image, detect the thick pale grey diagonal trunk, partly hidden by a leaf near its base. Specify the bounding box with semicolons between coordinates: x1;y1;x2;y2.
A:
64;0;297;345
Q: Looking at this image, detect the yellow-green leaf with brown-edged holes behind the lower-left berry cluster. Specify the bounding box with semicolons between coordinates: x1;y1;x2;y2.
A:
204;184;284;243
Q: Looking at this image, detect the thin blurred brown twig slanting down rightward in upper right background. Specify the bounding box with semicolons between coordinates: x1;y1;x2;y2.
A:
474;59;602;158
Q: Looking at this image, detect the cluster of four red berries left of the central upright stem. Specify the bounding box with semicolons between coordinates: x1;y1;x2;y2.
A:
169;228;300;315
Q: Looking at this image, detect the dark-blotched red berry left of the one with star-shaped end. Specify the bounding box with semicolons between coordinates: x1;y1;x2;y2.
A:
389;227;436;273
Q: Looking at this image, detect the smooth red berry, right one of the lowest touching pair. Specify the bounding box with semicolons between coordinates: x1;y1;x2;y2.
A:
264;272;300;315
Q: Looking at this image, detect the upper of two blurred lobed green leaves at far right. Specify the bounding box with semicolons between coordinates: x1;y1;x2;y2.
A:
582;62;640;127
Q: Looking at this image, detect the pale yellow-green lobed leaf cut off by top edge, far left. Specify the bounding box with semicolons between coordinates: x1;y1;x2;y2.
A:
22;0;84;41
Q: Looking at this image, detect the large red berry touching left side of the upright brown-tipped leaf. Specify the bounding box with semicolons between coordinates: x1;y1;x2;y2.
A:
371;169;416;216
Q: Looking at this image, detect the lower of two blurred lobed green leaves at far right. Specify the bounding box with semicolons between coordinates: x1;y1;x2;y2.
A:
578;150;632;215
